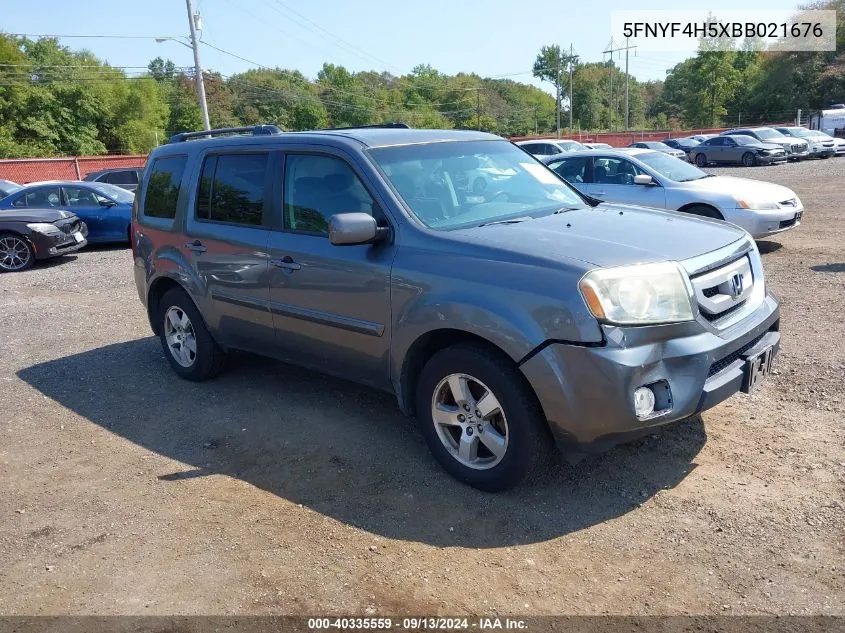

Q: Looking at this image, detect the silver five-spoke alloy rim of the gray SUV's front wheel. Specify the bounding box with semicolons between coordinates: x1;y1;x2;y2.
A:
431;374;508;470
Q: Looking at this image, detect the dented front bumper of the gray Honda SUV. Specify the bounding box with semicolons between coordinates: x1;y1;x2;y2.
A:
521;294;780;449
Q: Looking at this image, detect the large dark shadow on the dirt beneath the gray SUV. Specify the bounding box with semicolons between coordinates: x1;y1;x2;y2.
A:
18;337;707;547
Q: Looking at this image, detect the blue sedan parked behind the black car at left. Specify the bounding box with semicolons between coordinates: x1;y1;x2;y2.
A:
0;180;135;244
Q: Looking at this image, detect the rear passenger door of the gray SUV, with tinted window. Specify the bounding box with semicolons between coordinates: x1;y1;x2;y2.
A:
181;149;275;353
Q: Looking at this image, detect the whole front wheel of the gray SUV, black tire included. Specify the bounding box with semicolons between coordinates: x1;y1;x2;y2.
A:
415;344;552;492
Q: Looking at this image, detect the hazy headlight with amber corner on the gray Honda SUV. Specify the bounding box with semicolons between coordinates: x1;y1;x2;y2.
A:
579;262;693;325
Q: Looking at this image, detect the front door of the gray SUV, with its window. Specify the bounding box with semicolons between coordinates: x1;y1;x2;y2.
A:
269;153;395;387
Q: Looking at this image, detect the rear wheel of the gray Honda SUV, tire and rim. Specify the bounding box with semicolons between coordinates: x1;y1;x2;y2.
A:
158;288;226;382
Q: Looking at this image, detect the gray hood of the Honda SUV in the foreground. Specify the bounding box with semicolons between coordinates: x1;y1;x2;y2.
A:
454;204;747;267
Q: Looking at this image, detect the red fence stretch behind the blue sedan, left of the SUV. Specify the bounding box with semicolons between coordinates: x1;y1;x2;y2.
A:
0;155;147;185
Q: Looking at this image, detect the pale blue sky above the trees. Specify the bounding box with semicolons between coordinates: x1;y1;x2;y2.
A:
0;0;799;92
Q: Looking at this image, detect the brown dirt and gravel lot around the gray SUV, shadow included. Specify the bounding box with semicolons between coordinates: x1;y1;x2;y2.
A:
0;159;845;615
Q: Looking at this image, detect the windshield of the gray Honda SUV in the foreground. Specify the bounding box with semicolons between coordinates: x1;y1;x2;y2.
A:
370;140;588;230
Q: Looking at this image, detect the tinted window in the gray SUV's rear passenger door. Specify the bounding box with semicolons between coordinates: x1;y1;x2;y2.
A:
197;153;269;226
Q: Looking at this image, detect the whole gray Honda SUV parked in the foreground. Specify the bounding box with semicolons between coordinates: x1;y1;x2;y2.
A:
132;125;780;490
